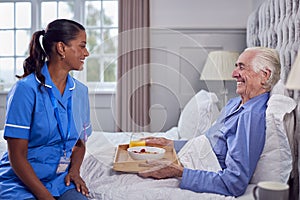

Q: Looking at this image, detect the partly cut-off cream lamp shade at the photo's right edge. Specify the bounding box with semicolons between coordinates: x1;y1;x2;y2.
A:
285;53;300;90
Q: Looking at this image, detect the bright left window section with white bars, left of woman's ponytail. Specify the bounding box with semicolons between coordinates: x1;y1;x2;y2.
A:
0;1;32;89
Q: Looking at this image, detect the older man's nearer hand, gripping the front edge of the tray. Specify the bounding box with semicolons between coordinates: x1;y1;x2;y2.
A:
138;160;183;179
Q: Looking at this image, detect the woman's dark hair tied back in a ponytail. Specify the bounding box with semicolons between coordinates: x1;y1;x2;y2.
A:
17;19;85;85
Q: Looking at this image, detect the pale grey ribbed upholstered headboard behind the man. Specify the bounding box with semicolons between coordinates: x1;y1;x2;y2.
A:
247;0;300;199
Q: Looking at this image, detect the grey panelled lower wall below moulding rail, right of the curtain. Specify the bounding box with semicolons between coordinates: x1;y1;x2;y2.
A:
150;28;246;131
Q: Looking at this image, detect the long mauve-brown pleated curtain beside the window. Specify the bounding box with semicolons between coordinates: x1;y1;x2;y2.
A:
116;0;150;131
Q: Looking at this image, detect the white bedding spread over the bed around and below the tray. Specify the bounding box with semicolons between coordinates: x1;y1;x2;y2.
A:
81;129;253;200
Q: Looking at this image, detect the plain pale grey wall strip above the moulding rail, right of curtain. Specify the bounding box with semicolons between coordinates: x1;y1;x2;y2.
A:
150;0;253;28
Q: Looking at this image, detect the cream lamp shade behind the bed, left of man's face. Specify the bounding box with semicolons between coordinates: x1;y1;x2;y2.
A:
200;51;239;80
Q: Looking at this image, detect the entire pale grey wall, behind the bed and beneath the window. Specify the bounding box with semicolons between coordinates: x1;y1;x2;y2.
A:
0;0;261;131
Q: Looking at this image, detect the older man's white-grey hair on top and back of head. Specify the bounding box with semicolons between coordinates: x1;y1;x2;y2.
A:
245;47;281;91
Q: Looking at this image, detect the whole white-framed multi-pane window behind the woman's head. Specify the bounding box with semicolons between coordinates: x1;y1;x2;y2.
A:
0;0;118;90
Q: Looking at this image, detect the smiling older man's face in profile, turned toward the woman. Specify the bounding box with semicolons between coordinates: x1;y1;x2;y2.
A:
232;51;265;103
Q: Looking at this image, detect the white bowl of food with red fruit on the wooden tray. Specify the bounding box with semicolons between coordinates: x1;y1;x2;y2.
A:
127;146;166;160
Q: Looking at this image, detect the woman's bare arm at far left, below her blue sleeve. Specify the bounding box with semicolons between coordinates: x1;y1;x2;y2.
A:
7;137;54;200
